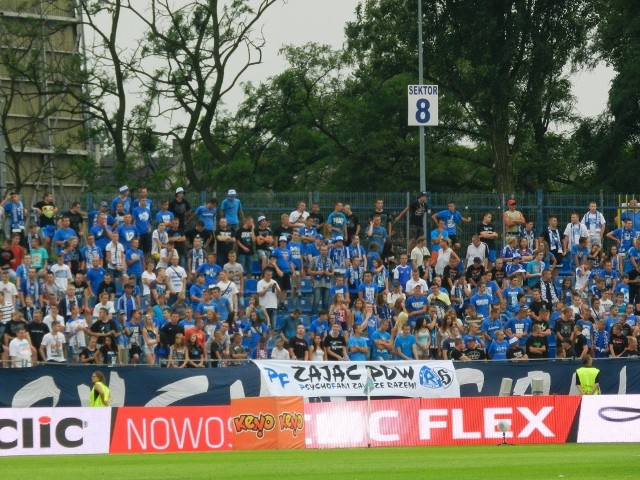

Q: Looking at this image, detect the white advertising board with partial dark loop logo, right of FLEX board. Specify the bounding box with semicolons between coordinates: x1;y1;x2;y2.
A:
578;395;640;443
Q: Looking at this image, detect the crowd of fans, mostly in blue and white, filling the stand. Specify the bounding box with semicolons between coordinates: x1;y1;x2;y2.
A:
0;186;640;368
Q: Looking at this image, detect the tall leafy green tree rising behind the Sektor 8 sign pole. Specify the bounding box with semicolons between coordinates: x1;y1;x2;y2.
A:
346;0;595;192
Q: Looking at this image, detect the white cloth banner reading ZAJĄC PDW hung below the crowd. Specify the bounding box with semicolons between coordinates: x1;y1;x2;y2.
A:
254;360;460;398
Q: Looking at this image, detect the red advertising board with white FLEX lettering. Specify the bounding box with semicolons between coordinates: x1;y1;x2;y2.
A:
305;396;580;448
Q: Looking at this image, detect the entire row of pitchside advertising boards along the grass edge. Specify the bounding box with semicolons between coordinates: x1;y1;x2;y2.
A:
0;395;640;456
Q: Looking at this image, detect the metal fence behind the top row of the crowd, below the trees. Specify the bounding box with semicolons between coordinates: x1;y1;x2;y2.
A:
8;190;640;252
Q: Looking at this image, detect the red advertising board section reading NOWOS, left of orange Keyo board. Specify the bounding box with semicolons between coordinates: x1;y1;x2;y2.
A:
110;406;232;453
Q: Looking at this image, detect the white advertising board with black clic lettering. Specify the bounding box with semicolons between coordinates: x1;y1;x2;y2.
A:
0;408;111;456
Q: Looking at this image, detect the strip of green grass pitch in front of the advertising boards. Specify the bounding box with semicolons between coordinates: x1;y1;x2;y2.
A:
0;444;640;480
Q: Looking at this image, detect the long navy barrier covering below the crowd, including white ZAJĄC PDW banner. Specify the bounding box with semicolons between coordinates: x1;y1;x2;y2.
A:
0;359;640;408
